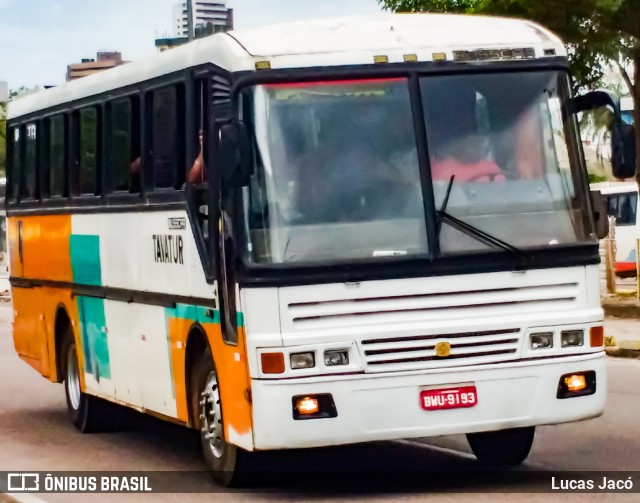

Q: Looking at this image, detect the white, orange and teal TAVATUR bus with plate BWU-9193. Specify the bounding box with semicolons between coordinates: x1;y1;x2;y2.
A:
7;15;628;484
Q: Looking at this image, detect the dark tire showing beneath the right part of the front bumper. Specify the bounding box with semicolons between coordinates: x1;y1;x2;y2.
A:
467;426;535;466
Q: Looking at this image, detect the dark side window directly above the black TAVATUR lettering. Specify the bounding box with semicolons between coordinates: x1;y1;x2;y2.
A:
152;86;185;189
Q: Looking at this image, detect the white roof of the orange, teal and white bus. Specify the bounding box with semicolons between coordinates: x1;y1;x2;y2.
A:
8;14;566;119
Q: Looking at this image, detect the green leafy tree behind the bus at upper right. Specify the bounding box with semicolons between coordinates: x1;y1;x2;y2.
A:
379;0;640;183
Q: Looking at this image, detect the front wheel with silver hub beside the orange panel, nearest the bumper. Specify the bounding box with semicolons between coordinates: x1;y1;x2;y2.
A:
192;348;250;487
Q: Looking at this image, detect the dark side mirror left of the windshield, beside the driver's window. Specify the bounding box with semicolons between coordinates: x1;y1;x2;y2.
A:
218;122;253;187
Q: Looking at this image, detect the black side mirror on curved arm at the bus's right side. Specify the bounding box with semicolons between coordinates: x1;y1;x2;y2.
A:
571;89;636;179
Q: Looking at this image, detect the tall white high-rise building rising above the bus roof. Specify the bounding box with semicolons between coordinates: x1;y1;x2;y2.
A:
173;0;233;38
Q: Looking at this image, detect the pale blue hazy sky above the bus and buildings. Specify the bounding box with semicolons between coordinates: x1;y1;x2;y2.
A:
0;0;381;89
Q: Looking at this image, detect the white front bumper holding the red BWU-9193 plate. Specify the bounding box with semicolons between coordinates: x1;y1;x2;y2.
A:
252;352;607;450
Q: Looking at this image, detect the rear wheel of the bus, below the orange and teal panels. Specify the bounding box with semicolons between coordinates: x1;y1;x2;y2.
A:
62;327;110;433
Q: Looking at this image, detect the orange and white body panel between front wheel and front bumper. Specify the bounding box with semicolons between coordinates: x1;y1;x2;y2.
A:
201;312;253;450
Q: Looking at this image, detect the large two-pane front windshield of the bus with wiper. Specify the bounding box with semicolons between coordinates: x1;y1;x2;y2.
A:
244;71;595;264
